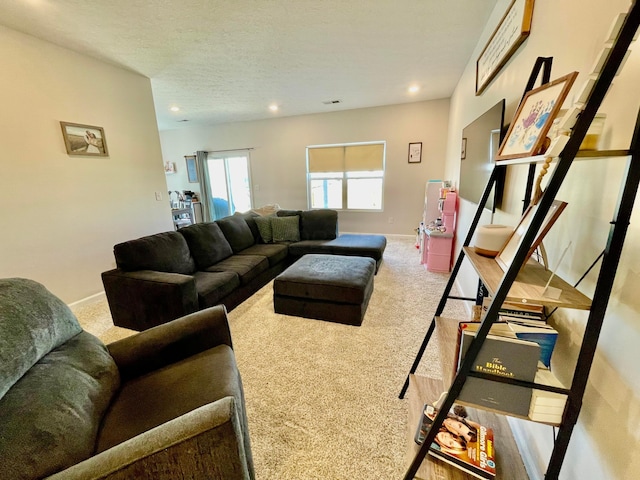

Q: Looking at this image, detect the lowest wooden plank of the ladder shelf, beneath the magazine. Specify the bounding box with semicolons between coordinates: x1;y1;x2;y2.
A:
407;375;529;480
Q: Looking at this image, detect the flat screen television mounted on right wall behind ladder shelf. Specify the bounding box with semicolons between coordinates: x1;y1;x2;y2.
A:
458;99;505;211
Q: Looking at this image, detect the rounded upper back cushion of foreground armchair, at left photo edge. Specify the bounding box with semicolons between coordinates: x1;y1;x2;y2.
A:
0;278;82;400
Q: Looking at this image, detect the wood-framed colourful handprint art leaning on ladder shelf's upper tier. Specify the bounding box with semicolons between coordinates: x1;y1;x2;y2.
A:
496;72;578;160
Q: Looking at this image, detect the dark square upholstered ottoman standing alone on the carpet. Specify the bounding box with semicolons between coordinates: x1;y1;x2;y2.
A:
273;254;376;325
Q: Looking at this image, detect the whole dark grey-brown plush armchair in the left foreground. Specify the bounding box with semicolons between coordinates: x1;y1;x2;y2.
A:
0;279;255;480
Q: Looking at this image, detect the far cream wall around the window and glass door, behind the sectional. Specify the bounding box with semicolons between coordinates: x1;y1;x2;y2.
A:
160;100;449;235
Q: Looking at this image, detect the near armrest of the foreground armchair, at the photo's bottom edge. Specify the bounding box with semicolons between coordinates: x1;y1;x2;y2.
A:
47;397;255;480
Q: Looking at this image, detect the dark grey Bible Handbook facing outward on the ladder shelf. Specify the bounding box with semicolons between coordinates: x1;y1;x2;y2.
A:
458;330;540;417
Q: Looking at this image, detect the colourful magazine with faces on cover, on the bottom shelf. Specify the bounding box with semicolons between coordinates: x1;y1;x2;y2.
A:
414;403;496;479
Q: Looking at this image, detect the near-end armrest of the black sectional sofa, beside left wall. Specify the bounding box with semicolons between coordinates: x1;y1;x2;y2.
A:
102;269;199;330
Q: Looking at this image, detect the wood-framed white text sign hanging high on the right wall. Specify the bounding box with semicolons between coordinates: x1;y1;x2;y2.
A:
476;0;534;95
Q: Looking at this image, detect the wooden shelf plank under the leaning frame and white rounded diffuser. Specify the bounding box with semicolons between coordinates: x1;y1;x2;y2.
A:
463;247;591;310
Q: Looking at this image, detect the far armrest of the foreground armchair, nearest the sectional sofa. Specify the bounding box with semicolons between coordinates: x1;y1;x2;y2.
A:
107;305;233;380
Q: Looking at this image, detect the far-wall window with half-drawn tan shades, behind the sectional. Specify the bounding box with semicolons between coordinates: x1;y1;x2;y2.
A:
307;142;386;210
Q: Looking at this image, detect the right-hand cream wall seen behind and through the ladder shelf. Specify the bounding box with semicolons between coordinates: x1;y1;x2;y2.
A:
445;0;640;480
